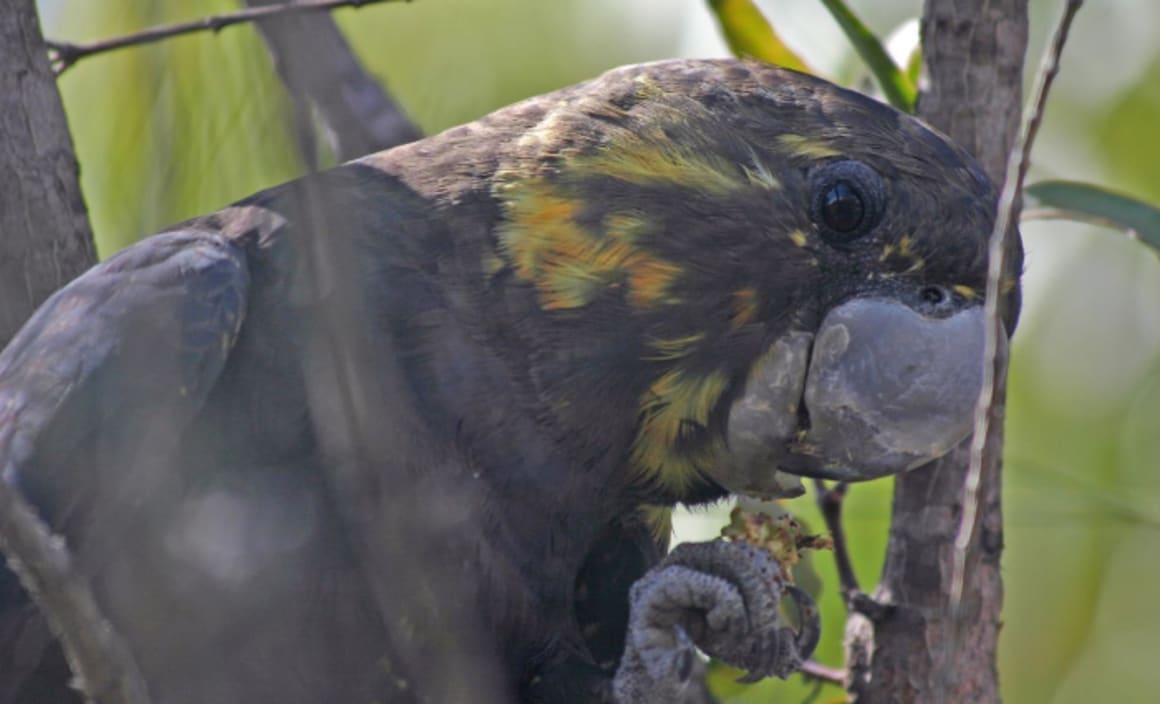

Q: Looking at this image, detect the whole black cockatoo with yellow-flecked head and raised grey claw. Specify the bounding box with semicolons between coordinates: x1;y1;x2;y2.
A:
0;60;1021;704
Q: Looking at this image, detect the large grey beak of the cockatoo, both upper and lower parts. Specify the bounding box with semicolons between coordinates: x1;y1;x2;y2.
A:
713;298;992;496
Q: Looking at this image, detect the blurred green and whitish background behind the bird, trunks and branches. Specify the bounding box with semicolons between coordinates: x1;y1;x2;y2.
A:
41;0;1160;704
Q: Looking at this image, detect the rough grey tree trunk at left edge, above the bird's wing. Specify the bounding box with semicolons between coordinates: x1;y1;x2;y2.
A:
0;0;96;348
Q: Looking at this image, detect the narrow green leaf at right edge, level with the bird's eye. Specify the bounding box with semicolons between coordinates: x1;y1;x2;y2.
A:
1023;181;1160;251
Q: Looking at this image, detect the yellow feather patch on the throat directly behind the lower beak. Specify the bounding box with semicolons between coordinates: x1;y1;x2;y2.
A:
631;369;728;488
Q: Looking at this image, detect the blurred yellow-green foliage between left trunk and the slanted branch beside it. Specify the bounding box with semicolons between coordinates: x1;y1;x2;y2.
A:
44;0;302;255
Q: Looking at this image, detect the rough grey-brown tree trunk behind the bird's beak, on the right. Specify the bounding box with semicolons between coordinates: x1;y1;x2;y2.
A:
847;0;1028;704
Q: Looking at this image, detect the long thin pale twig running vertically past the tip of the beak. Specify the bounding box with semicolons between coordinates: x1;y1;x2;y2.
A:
950;0;1083;609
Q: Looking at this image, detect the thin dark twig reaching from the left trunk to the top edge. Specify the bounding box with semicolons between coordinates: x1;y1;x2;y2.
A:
45;0;411;75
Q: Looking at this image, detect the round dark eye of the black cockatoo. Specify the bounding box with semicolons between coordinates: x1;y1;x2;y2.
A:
811;161;885;242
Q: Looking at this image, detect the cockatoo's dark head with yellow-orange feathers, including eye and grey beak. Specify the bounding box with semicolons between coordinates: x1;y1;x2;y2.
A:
385;60;1022;495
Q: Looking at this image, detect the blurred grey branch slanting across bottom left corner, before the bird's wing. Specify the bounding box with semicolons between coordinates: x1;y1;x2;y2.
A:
0;470;150;704
